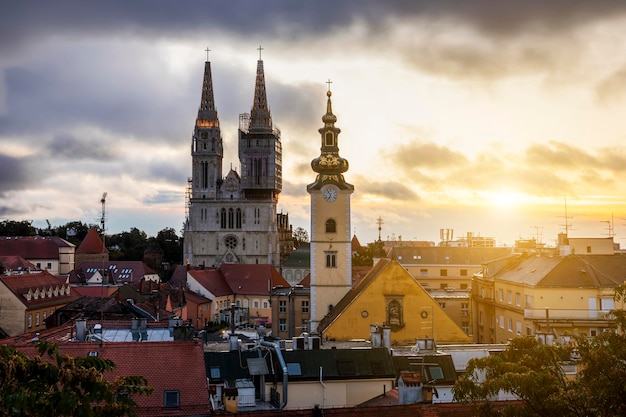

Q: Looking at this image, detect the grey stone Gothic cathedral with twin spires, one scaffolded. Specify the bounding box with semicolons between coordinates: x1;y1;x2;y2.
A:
183;48;293;270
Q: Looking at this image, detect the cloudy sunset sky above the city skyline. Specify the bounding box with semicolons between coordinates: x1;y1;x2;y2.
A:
0;0;626;246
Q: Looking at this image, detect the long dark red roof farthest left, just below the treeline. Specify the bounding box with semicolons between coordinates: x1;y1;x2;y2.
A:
0;236;74;259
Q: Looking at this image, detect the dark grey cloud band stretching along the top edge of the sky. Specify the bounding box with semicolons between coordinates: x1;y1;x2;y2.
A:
0;0;626;50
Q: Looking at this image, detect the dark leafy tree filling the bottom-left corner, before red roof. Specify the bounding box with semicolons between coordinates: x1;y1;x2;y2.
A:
0;342;153;417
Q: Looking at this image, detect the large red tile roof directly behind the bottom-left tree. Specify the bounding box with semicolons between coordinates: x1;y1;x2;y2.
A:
9;341;209;417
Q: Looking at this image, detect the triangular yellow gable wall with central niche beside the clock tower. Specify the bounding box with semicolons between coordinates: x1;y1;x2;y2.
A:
322;260;471;343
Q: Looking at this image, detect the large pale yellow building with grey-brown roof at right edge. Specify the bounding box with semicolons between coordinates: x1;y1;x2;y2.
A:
472;242;626;343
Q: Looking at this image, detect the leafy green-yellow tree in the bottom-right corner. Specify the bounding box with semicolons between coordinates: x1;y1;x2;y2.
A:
453;286;626;417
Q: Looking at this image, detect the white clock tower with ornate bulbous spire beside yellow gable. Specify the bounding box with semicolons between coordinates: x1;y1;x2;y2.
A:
307;86;354;332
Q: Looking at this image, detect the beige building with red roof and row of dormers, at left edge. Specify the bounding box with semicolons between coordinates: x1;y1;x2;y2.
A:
0;271;78;336
